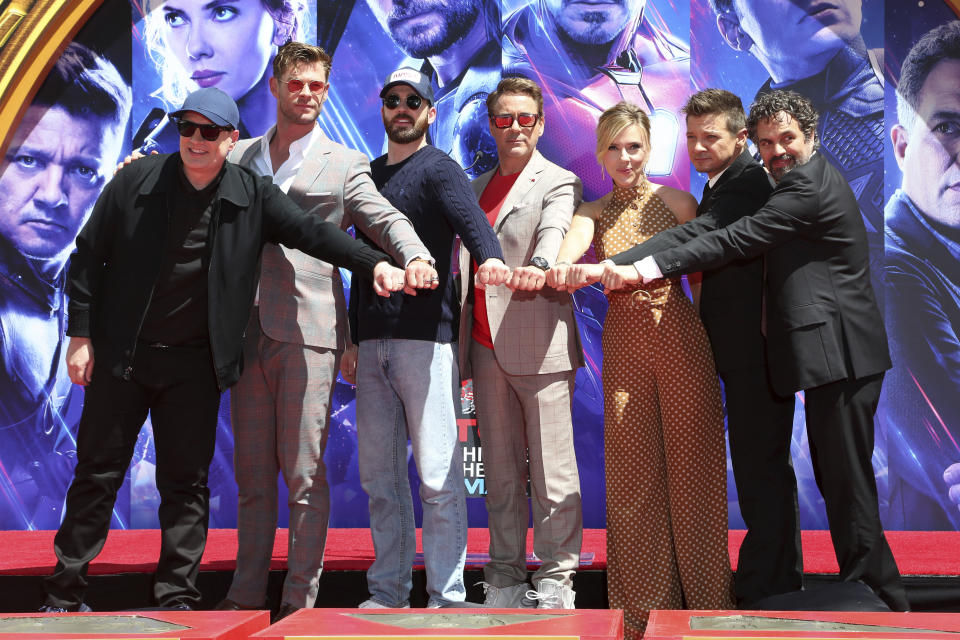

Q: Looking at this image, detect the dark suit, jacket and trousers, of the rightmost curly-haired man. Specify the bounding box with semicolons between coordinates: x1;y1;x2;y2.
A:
654;154;908;610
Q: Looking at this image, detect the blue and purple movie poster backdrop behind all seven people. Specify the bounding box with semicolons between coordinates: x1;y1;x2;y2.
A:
0;0;960;529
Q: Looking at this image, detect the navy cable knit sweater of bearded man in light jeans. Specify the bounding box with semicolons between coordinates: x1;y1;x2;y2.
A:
350;145;503;344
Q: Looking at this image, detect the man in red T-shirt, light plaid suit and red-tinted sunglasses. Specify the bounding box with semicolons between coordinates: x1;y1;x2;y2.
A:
459;78;583;609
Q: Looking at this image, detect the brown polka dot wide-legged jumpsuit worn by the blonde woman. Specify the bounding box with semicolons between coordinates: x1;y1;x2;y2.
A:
594;181;733;638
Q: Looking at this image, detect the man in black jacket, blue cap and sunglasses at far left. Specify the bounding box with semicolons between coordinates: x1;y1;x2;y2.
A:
41;88;403;612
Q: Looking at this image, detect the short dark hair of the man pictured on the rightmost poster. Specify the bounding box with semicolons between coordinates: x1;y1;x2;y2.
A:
897;20;960;129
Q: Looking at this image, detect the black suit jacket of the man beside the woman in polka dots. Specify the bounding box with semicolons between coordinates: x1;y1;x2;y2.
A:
611;151;773;374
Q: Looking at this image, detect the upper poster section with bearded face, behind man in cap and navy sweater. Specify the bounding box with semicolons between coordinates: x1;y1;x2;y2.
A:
321;0;501;178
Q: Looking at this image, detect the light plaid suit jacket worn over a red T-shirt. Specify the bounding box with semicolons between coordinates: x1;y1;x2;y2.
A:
460;151;583;379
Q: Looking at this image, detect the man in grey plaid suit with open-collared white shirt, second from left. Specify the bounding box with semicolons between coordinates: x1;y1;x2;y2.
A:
217;42;437;619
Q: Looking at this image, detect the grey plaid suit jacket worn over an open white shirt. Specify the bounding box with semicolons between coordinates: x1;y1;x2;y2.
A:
227;129;430;350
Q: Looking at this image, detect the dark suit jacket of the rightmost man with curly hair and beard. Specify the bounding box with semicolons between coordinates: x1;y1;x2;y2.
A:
654;153;890;395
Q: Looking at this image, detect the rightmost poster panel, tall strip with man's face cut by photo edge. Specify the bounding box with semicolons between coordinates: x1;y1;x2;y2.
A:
883;0;960;530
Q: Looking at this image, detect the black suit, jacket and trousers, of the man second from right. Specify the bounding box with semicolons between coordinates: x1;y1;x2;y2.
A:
611;151;803;604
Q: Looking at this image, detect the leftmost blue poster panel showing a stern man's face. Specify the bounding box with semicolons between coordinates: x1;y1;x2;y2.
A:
0;2;131;530
